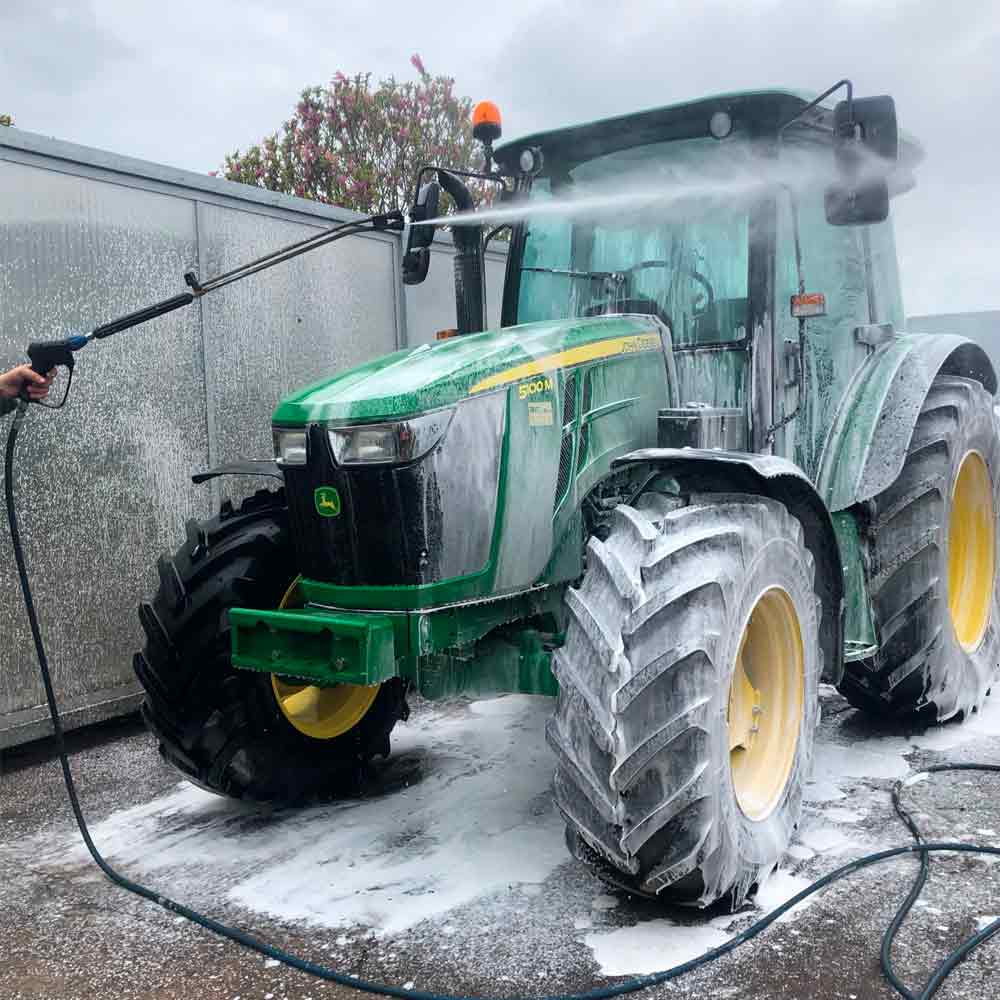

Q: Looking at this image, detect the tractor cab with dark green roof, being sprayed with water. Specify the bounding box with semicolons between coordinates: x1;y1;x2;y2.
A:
495;91;921;472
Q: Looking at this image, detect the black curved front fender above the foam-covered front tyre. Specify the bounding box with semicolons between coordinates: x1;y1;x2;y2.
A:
614;448;844;684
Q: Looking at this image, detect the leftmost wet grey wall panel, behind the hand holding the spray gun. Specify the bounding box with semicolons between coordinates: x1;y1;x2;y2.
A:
0;154;207;745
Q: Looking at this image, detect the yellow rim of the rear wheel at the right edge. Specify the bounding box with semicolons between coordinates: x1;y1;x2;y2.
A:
948;451;996;651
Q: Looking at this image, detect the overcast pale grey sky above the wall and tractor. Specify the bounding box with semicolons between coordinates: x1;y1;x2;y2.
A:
0;0;1000;315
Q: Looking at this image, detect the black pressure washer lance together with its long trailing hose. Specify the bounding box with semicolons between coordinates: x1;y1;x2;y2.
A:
4;205;1000;1000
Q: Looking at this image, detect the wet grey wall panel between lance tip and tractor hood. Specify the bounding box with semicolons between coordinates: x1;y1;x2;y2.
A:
198;205;400;496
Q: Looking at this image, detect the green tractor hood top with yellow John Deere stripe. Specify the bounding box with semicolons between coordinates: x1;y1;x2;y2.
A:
272;315;669;427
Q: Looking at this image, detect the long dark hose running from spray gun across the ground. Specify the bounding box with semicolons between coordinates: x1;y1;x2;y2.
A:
4;401;1000;1000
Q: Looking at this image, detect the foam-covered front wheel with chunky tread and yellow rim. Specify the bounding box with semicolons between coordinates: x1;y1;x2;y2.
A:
547;494;822;906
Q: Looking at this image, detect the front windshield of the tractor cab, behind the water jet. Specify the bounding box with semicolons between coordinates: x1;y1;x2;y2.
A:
517;137;752;346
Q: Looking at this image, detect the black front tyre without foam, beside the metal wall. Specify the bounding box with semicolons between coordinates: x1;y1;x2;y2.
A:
134;490;407;804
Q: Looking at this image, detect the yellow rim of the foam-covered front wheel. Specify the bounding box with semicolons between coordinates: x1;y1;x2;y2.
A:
726;587;804;821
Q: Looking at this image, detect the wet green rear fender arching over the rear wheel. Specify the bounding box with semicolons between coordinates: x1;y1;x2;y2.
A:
816;334;997;511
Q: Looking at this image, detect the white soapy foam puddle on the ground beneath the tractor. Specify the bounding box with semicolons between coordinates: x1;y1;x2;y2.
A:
20;687;1000;978
